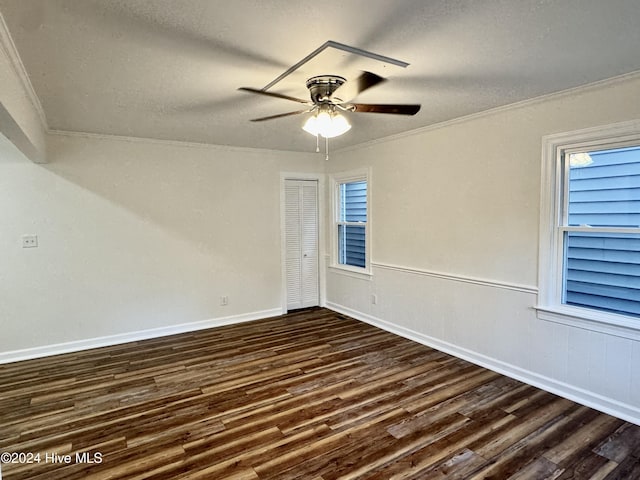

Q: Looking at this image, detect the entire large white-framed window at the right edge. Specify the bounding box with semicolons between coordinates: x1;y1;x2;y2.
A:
538;122;640;337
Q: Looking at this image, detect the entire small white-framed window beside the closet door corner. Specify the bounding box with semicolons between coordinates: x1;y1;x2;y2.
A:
331;171;371;274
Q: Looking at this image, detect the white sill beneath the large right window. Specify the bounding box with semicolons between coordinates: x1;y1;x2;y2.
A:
534;305;640;340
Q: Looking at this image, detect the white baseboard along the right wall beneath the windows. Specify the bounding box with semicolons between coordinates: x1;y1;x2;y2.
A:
327;302;640;425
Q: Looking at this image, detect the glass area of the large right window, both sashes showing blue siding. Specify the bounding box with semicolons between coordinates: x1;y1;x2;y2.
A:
559;146;640;317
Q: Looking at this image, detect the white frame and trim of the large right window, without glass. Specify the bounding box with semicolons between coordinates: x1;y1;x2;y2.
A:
535;120;640;339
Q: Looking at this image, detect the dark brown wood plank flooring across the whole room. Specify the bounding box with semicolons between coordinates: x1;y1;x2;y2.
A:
0;309;640;480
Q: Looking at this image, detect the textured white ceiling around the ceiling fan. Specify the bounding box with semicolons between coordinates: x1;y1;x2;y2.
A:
0;0;640;151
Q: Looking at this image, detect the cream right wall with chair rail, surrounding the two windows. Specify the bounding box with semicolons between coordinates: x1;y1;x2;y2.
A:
327;75;640;423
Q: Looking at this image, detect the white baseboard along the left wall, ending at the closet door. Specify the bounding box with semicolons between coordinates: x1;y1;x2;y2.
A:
0;307;282;364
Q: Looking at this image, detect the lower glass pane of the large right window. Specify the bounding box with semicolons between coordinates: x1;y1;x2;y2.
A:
563;232;640;317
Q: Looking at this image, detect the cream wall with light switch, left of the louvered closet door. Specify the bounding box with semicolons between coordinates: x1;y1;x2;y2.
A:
0;134;324;361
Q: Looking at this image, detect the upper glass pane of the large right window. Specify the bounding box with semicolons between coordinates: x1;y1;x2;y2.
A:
568;147;640;228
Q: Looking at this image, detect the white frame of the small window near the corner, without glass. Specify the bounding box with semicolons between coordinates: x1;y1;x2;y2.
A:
329;169;372;279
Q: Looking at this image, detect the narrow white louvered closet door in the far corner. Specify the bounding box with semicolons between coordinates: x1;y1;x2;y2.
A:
285;180;319;310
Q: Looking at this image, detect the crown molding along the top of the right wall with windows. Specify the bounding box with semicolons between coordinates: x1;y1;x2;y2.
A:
334;70;640;153
